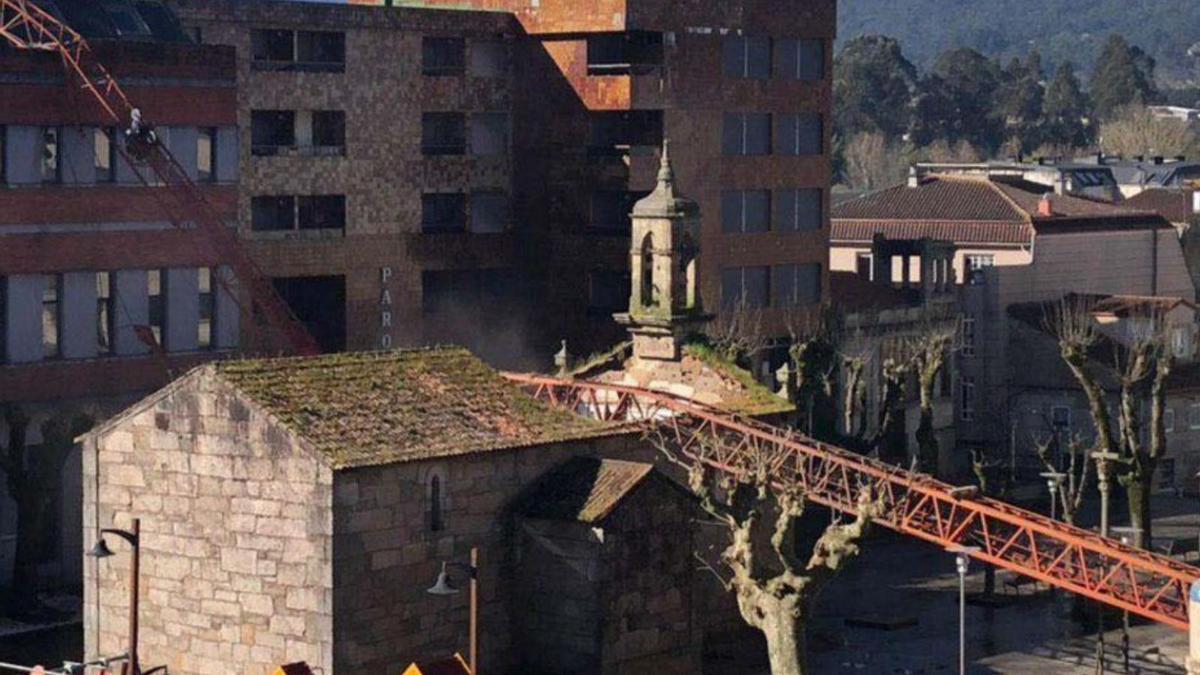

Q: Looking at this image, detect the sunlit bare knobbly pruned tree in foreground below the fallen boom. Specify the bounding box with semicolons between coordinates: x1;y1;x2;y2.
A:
648;425;882;675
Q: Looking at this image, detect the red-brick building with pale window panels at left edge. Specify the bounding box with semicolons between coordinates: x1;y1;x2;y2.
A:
0;0;239;584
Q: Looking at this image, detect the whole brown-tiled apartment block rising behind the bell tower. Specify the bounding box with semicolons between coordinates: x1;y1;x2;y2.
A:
174;0;835;364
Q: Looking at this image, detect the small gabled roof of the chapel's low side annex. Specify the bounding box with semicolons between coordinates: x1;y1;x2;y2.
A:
522;458;654;524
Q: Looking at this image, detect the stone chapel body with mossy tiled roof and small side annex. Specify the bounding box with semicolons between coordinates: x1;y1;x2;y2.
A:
83;348;700;675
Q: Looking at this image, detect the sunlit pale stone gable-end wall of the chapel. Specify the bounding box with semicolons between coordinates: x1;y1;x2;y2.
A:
83;371;332;675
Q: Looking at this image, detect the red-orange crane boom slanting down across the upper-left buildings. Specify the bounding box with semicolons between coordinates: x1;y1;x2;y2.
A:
0;0;320;356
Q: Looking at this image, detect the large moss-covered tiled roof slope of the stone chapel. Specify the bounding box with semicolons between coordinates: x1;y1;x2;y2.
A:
210;348;616;468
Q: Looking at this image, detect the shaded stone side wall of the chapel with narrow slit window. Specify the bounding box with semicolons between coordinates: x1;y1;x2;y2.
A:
334;437;654;673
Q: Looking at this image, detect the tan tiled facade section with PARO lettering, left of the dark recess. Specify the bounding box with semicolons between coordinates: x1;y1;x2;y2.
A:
175;0;528;364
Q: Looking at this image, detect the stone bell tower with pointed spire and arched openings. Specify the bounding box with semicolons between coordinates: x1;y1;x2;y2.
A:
614;142;713;360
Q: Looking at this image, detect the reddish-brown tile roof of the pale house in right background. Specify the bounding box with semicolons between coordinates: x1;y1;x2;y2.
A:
830;175;1169;245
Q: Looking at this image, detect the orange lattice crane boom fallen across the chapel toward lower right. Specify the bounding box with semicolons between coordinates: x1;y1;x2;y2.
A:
506;374;1200;631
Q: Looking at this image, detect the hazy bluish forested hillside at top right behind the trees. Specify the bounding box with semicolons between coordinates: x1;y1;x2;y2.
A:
838;0;1200;84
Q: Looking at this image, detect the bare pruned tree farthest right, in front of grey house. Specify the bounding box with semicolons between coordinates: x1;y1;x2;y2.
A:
1046;297;1175;546
